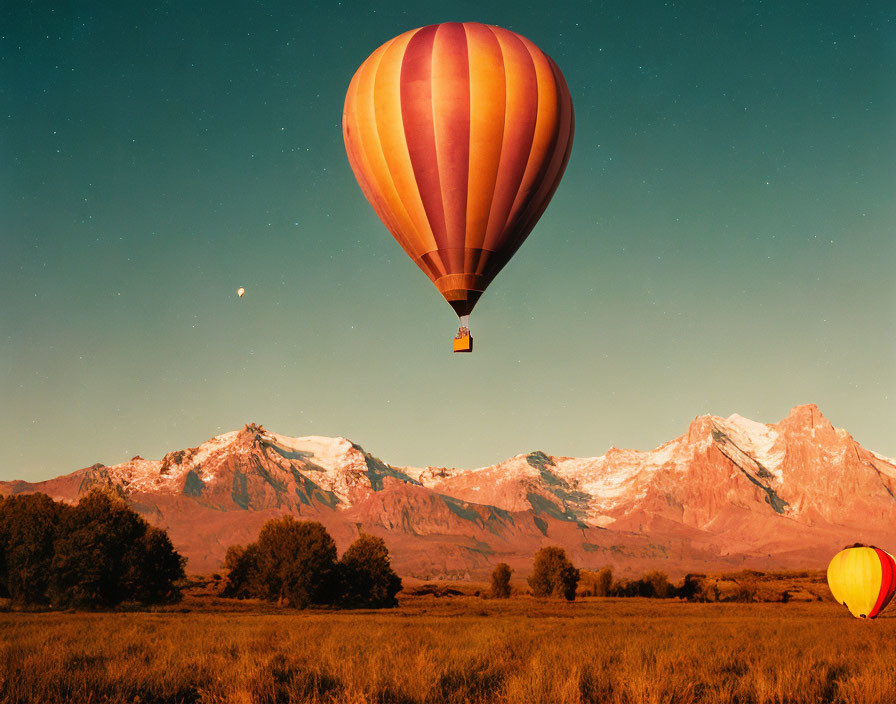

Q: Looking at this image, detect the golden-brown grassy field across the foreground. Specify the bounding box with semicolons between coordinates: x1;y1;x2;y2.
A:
0;596;896;704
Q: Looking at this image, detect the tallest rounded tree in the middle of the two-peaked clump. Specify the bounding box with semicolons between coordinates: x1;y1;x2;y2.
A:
258;516;338;609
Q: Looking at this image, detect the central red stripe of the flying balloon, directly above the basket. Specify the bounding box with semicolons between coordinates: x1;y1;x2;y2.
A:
431;22;470;271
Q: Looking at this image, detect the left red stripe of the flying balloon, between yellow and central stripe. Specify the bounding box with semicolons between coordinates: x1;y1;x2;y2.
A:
401;25;450;258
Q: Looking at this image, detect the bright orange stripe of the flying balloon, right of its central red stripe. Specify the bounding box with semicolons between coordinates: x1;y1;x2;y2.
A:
464;22;507;256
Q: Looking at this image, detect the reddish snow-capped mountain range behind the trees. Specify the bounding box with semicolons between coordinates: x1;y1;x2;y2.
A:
0;405;896;579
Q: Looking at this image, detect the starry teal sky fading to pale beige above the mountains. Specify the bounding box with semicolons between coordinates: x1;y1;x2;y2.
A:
0;0;896;480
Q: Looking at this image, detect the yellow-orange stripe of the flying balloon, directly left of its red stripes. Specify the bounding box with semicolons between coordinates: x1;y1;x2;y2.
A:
365;30;436;254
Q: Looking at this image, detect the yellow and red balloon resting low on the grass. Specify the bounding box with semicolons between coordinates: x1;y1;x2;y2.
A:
828;544;896;618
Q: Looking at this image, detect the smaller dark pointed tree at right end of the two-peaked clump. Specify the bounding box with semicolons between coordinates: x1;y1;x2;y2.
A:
339;534;401;609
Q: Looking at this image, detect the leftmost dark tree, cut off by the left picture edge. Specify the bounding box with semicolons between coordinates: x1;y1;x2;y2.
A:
0;494;71;604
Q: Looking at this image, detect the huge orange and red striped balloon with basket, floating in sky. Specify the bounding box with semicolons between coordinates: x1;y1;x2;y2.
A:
342;22;574;352
